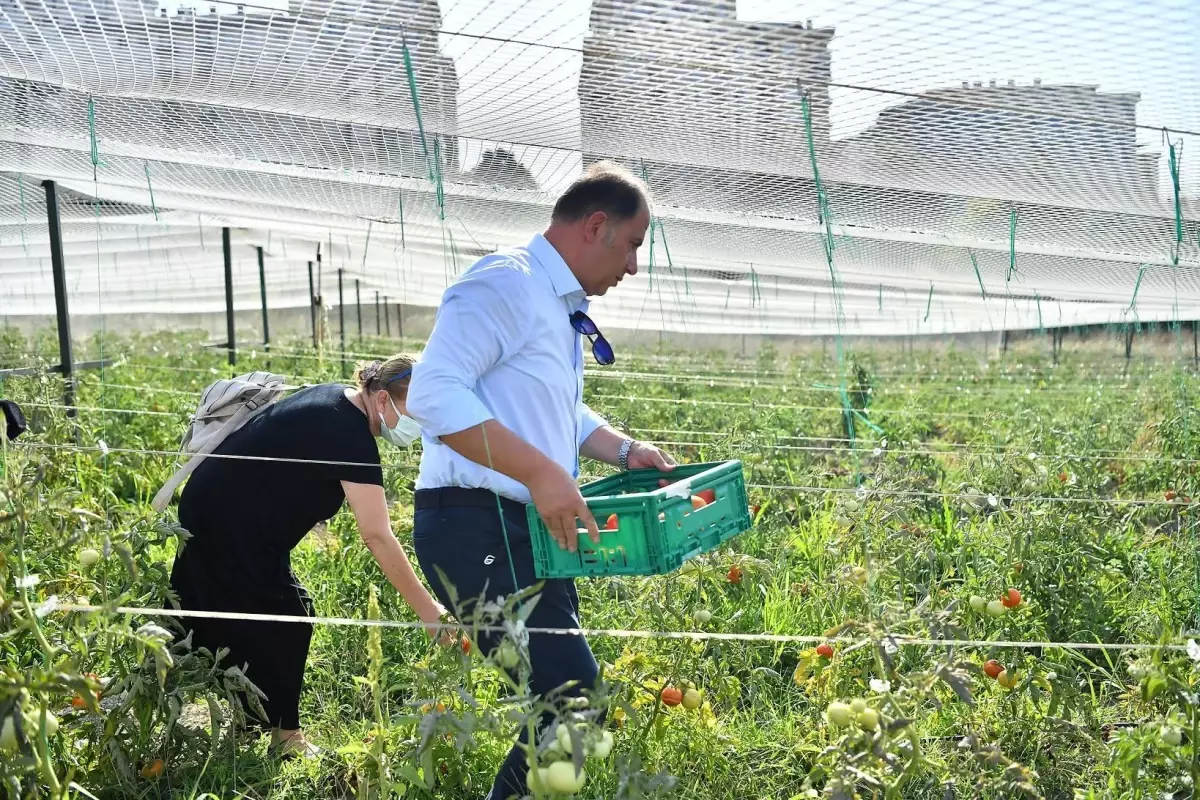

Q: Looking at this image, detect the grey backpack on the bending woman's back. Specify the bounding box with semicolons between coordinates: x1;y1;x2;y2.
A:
152;372;293;511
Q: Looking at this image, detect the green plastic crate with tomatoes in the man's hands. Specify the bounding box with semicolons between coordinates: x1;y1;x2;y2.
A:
526;461;750;578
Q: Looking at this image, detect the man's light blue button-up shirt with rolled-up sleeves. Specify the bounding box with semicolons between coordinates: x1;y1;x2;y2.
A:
407;234;606;503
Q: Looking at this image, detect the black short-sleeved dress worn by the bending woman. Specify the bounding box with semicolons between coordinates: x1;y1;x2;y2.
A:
170;384;383;729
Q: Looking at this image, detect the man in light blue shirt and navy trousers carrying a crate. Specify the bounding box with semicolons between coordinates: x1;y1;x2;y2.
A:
408;163;674;800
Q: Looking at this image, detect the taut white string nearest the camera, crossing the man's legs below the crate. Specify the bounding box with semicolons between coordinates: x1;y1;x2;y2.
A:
39;602;1187;651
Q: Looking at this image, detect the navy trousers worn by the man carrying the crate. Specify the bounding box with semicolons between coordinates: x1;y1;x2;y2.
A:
413;488;600;800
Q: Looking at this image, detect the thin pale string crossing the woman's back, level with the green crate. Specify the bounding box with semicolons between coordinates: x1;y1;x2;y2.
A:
12;440;1188;507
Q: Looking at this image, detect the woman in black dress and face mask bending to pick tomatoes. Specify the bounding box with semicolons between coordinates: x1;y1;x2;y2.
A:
170;355;445;756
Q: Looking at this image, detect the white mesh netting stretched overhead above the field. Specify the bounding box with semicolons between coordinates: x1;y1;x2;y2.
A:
0;0;1200;335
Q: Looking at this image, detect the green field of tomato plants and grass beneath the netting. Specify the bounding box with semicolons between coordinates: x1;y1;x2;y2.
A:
0;332;1200;800
